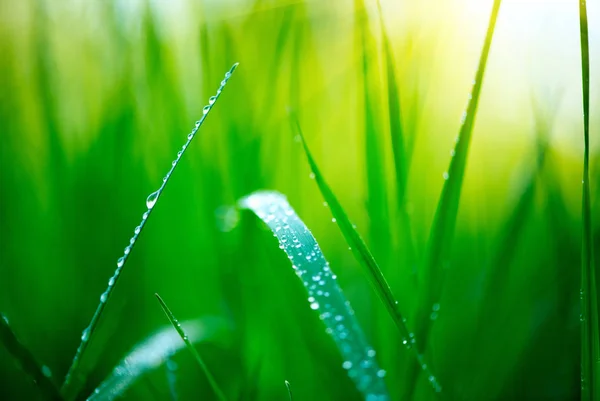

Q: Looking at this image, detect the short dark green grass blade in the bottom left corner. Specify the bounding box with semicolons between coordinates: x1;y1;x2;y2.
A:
0;313;62;400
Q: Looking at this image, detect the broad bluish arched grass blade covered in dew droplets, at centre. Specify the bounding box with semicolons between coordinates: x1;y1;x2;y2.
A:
239;191;389;401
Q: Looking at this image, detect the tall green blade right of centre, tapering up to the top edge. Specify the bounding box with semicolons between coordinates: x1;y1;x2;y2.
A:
416;0;501;351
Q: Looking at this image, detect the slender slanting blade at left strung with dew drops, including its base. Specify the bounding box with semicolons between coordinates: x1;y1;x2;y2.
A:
61;63;238;400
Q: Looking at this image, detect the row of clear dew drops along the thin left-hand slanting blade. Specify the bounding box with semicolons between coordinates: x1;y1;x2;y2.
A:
81;63;239;343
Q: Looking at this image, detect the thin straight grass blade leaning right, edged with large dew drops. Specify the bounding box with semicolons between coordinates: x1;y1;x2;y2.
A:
63;63;238;387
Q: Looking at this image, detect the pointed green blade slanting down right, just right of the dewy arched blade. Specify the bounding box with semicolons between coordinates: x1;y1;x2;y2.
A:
292;115;442;392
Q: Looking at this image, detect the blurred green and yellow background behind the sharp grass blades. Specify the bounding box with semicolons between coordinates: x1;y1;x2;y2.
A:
0;0;600;400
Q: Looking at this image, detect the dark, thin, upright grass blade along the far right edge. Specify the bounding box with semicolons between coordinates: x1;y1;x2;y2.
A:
579;0;600;400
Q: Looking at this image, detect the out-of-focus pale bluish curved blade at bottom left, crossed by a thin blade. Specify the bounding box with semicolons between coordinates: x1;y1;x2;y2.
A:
88;318;226;401
